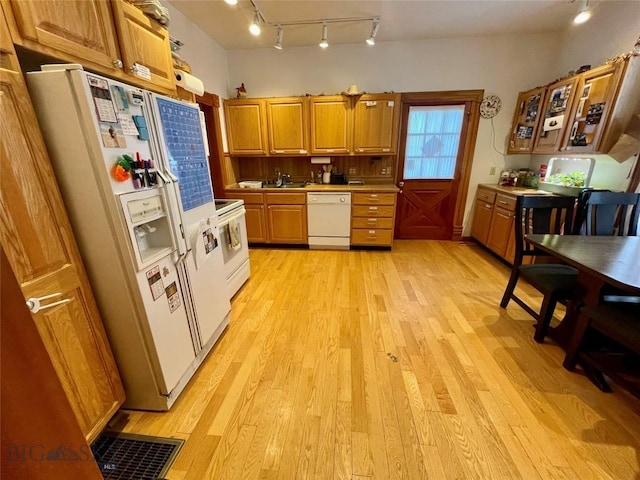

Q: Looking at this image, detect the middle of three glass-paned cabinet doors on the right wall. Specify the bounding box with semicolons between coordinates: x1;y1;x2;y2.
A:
533;77;579;153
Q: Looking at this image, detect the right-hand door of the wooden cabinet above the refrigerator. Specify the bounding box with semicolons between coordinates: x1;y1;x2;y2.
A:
113;0;176;91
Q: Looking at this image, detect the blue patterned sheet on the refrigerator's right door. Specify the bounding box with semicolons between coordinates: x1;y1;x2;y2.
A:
157;98;213;212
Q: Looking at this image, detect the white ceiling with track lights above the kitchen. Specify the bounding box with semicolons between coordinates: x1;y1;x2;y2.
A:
166;0;592;50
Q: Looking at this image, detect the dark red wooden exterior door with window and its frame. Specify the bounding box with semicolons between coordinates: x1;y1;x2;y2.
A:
395;90;483;240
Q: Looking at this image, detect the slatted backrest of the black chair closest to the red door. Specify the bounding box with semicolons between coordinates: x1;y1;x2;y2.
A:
514;195;576;266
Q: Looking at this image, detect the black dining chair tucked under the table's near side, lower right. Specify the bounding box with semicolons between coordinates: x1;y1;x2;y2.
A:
563;303;640;395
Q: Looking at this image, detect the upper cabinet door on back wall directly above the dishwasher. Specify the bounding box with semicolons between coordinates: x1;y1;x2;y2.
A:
310;95;353;154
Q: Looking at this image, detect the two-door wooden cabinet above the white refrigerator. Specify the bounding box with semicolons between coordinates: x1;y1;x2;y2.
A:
1;0;176;94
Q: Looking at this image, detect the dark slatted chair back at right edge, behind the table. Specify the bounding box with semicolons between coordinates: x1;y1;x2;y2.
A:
585;192;640;236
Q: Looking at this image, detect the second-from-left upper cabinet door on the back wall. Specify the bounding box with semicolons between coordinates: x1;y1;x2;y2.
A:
266;97;309;155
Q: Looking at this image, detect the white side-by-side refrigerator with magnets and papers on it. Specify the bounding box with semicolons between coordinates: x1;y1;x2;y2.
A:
27;65;230;410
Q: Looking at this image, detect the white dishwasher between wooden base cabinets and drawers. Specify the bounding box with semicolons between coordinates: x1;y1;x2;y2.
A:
307;192;351;250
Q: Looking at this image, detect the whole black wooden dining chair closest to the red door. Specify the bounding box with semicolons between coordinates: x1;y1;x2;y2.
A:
500;195;578;343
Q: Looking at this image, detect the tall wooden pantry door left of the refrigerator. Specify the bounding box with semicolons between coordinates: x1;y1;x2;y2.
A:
0;65;124;440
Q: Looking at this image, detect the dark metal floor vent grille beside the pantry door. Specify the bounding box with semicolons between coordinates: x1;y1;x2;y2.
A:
91;432;184;480
